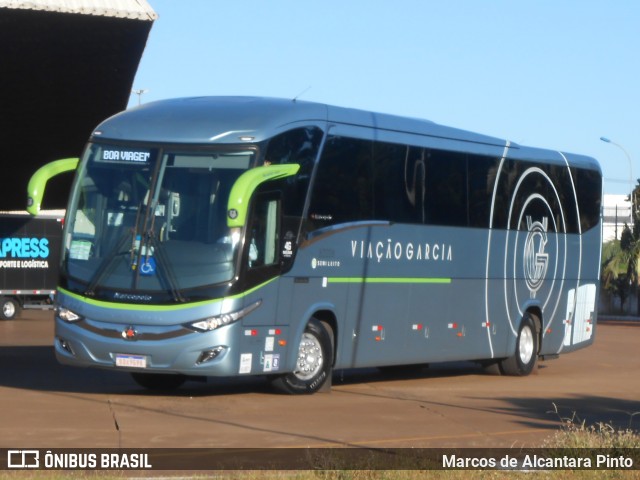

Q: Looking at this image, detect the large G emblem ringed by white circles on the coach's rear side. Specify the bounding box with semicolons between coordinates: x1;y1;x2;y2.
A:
485;158;582;350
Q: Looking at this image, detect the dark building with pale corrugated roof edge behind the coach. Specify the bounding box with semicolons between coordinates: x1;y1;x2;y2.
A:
0;0;157;210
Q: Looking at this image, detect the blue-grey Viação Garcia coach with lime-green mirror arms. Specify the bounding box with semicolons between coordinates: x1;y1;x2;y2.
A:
29;97;602;393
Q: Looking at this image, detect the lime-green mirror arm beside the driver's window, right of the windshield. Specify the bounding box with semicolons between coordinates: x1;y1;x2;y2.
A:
227;163;300;228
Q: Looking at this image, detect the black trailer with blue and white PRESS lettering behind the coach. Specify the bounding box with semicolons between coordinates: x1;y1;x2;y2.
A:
0;212;63;320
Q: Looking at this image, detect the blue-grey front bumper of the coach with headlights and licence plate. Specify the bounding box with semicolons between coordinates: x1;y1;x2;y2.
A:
55;317;285;377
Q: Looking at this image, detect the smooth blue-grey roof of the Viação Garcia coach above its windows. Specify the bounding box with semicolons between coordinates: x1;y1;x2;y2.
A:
93;96;600;170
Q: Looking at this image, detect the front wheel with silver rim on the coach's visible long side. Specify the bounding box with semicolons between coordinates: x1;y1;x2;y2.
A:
273;318;333;395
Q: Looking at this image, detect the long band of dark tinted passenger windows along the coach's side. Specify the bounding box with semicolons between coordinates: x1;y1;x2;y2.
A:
309;133;601;233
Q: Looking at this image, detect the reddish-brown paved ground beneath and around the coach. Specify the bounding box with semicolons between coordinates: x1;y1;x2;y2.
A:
0;311;640;448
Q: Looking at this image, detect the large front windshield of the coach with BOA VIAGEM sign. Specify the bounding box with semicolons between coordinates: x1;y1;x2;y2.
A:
63;143;256;301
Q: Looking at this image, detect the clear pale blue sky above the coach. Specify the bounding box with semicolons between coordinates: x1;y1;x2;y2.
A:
130;0;640;194
